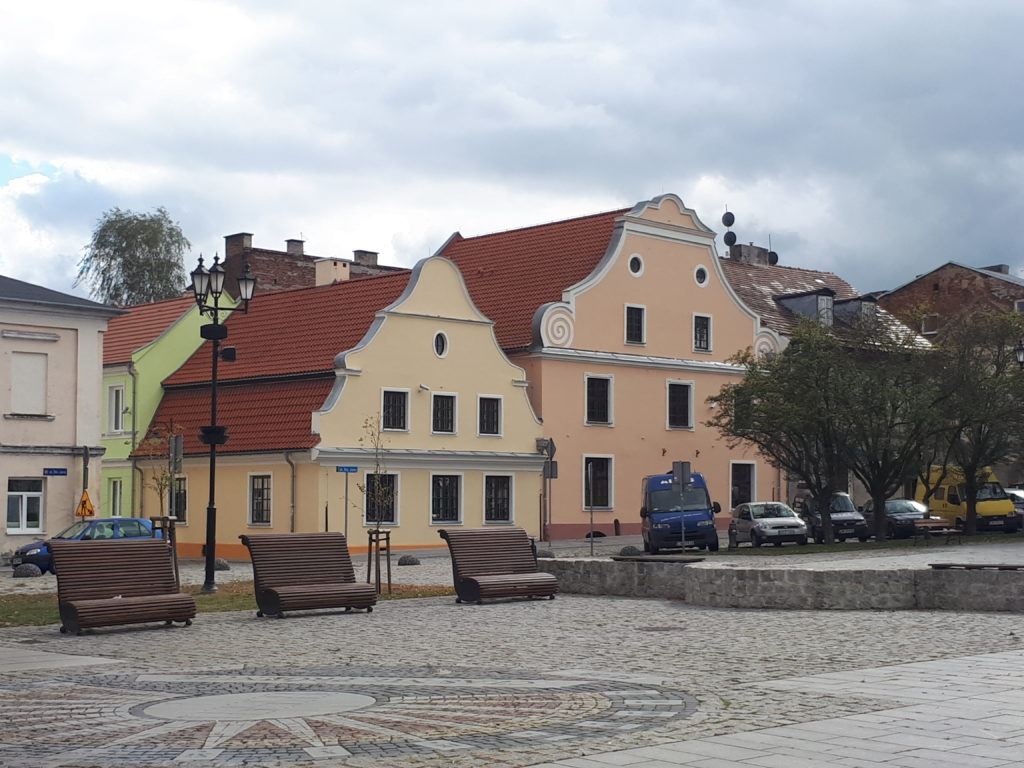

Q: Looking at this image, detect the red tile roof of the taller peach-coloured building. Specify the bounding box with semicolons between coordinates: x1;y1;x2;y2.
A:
441;208;630;351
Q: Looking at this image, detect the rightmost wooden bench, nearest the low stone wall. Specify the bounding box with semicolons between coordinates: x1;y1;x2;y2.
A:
439;528;558;604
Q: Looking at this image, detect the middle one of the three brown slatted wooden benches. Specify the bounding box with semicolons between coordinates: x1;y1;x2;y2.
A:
239;534;377;618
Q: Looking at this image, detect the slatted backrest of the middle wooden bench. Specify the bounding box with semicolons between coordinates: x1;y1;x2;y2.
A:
239;534;355;591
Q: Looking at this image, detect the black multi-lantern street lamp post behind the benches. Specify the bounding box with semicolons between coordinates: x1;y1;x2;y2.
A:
191;255;256;593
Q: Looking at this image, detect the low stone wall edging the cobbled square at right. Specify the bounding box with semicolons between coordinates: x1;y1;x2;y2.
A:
539;559;1024;611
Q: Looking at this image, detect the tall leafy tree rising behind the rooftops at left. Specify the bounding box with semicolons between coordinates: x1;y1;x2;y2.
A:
75;208;191;306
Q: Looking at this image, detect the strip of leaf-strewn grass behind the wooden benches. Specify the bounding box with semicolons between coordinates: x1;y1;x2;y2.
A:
0;582;455;627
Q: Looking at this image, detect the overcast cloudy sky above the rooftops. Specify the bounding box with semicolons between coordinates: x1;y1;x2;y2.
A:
0;0;1024;293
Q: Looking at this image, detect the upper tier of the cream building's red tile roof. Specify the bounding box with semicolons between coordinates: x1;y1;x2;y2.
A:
164;270;410;386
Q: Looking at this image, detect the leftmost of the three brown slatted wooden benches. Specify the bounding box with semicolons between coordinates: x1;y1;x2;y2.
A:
50;539;196;635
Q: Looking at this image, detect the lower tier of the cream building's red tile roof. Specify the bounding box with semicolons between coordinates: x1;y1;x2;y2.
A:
144;376;325;455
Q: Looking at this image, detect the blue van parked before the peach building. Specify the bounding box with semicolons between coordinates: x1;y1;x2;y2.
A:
640;472;722;555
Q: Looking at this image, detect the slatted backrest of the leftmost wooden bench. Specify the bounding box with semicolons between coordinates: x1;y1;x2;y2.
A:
50;539;178;602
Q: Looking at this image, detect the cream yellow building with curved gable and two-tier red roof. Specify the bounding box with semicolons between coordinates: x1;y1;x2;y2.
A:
146;257;545;557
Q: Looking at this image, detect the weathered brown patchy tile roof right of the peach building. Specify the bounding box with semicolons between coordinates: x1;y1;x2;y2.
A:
719;258;858;334
